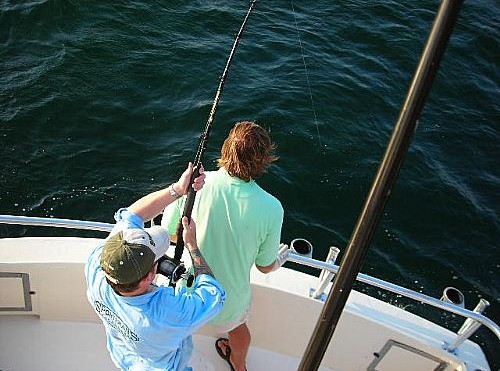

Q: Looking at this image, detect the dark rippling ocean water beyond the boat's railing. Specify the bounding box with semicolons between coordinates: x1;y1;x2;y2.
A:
0;0;500;370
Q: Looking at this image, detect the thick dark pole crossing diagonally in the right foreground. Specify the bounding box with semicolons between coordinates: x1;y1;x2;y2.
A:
298;0;462;371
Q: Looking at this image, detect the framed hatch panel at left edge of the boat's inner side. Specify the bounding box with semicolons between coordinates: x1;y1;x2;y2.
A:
0;272;33;312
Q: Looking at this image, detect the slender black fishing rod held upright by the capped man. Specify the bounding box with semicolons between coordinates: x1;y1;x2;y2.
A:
174;0;257;262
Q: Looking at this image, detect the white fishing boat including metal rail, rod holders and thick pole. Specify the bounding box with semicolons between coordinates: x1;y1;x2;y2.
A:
0;1;500;371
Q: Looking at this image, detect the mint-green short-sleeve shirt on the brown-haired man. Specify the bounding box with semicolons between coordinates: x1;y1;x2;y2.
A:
162;169;283;324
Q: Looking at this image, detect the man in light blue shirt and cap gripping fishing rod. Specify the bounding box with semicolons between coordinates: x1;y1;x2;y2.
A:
85;164;225;371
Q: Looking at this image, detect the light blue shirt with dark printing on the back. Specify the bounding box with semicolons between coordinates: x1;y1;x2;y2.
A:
85;209;225;371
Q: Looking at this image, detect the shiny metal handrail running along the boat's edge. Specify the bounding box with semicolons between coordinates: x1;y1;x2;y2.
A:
0;215;500;340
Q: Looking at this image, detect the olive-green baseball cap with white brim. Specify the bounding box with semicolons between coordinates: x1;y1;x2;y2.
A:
101;226;170;284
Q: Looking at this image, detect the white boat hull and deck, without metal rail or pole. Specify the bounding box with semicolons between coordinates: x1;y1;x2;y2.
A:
0;237;490;371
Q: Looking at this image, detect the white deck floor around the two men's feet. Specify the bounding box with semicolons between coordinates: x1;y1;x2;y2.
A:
0;316;333;371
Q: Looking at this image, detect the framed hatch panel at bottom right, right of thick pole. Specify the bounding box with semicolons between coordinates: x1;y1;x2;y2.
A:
367;340;448;371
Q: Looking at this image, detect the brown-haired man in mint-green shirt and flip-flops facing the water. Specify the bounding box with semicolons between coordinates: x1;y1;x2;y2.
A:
162;121;288;371
